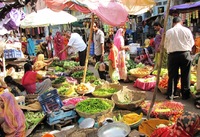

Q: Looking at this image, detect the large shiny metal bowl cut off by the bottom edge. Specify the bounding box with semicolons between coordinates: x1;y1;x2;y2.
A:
98;122;131;137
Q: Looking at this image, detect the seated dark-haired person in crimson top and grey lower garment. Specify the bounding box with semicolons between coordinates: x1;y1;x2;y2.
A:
22;63;52;94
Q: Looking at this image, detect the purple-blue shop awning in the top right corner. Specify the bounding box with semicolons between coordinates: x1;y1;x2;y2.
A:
170;1;200;14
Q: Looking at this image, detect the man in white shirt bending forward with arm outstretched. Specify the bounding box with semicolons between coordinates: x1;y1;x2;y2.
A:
60;31;87;66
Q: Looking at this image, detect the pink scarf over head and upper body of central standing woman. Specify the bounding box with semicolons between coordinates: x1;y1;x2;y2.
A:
114;28;124;51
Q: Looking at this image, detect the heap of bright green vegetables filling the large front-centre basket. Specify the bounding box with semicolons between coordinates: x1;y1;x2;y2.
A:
76;98;112;114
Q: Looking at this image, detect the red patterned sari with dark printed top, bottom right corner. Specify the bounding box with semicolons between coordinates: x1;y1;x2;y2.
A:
151;112;200;137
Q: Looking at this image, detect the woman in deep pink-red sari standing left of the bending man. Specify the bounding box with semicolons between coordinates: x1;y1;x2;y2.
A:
54;32;67;60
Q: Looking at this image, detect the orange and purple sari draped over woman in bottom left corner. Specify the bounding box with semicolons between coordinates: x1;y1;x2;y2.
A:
0;92;25;137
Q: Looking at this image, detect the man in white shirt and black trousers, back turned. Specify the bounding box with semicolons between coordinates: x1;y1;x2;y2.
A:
164;17;194;100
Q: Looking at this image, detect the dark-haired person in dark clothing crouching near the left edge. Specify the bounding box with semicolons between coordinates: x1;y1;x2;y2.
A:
4;76;26;96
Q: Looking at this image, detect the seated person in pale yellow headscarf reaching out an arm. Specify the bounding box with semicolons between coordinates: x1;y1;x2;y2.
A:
33;52;53;71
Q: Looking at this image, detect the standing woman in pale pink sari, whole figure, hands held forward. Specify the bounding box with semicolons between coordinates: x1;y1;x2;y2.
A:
114;28;129;82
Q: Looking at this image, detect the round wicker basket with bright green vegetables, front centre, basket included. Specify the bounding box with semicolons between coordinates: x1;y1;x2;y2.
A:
76;98;115;118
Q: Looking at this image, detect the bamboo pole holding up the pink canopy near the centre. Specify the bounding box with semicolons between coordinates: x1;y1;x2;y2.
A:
82;14;94;83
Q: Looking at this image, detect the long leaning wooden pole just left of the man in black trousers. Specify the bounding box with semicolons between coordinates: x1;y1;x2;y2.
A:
147;0;171;119
